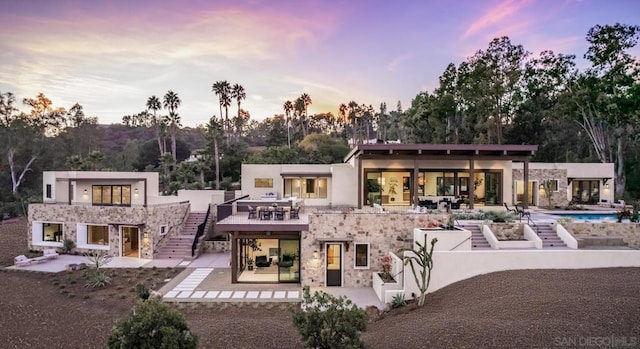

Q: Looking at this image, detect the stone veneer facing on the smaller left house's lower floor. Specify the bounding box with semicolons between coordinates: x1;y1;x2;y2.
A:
27;203;189;259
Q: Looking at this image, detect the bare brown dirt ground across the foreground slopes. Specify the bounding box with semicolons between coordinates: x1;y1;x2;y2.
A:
0;216;640;349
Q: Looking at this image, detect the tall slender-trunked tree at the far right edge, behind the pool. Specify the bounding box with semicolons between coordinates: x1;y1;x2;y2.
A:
572;23;640;197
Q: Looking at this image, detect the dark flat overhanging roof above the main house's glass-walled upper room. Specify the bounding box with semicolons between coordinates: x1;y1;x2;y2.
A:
344;144;538;162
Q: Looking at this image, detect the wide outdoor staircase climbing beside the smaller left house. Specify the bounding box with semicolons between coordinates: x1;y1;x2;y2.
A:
155;212;207;260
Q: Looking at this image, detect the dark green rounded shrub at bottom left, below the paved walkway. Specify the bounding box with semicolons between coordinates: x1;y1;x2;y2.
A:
107;300;198;349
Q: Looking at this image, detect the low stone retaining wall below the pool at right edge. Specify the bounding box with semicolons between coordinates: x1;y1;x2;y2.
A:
562;222;640;249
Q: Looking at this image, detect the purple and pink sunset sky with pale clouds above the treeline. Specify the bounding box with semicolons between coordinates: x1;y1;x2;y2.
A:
0;0;640;126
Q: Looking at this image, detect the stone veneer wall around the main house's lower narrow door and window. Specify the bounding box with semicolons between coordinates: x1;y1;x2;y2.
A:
300;212;451;287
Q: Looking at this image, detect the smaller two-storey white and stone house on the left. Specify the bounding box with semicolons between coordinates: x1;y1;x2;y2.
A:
28;171;190;259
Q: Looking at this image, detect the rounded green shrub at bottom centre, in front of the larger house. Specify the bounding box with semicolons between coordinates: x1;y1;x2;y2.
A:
293;286;367;348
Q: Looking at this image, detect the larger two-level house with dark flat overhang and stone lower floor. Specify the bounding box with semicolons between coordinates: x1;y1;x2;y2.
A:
215;144;614;287
